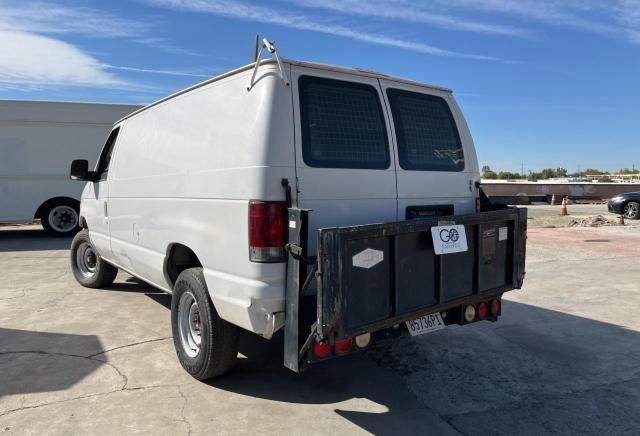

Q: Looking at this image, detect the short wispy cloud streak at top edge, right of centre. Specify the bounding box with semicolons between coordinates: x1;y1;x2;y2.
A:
291;0;531;36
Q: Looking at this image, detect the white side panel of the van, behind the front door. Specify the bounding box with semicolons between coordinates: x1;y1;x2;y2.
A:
108;65;295;333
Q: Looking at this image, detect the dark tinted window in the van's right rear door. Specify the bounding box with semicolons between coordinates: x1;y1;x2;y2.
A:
387;89;464;171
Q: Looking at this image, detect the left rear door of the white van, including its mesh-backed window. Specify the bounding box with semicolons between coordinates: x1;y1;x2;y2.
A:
291;66;398;253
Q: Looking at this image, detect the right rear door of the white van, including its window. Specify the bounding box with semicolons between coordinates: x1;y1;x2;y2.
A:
380;80;478;220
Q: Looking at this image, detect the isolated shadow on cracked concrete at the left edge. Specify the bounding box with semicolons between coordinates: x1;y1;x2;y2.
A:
0;328;104;398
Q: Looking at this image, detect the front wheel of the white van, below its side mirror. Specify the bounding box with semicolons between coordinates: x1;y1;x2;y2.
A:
70;230;118;288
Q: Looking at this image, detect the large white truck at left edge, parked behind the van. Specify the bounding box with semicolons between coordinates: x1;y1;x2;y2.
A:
0;100;140;235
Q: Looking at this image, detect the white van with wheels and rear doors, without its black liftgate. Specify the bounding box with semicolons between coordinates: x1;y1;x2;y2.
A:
71;46;520;379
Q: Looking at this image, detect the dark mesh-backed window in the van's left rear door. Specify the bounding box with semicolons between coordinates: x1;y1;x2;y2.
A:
299;76;390;169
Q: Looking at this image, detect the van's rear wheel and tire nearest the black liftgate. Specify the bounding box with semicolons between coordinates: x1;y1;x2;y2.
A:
171;268;239;380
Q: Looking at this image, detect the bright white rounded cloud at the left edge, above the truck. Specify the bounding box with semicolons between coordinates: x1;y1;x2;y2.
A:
0;30;127;88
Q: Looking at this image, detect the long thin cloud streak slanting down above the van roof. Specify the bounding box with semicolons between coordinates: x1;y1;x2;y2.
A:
144;0;499;60
